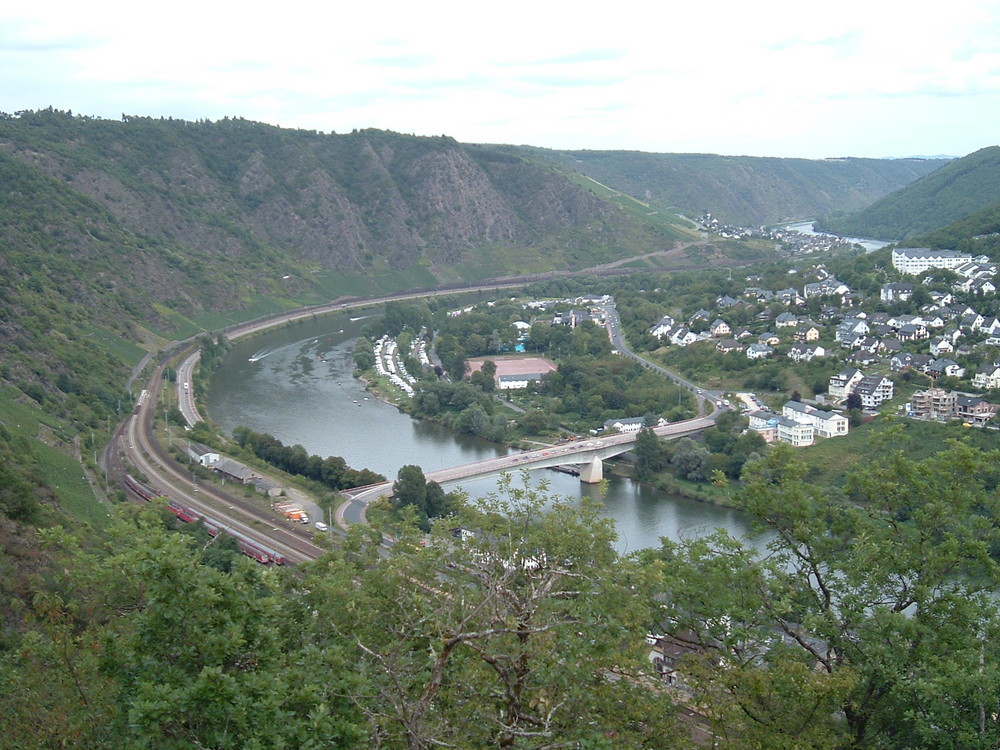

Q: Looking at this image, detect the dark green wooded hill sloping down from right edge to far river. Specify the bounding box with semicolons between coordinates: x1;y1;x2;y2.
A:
820;146;1000;242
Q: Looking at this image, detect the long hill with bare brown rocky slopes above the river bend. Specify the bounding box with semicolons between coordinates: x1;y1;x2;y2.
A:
0;111;681;296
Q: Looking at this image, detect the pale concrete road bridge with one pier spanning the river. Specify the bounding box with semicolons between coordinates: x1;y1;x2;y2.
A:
336;412;718;528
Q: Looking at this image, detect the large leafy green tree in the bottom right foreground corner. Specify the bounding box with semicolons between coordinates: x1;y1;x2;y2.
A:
663;444;1000;748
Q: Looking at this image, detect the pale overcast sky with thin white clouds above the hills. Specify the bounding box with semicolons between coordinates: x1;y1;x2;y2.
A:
0;0;1000;158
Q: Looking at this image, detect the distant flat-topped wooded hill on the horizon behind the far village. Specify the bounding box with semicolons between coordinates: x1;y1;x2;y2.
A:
518;148;947;226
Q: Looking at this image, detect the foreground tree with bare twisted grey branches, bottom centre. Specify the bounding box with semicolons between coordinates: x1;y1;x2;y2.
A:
312;477;686;748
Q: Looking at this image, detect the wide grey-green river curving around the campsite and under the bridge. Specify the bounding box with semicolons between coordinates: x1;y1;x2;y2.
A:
206;312;750;552
